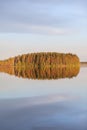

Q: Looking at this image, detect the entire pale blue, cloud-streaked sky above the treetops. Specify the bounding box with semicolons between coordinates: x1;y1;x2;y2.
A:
0;0;87;61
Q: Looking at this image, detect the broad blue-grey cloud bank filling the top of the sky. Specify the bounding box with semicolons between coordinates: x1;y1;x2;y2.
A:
0;0;87;34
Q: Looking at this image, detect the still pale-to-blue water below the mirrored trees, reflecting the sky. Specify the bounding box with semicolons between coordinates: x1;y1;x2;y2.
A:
0;67;87;130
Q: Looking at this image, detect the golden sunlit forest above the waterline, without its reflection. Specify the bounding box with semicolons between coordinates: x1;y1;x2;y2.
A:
0;52;80;68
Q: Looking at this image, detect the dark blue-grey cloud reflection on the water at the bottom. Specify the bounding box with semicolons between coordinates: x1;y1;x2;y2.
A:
0;95;87;130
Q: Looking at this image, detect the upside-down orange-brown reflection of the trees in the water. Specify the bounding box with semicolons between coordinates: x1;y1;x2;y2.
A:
0;66;80;79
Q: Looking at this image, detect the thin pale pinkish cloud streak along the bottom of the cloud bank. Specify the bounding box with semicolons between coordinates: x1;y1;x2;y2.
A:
1;23;77;35
